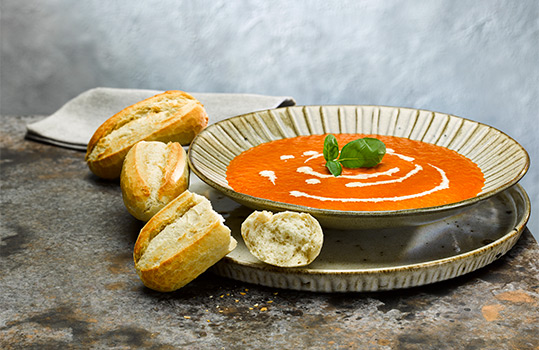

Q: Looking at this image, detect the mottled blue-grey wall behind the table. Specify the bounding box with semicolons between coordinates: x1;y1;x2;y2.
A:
0;0;539;235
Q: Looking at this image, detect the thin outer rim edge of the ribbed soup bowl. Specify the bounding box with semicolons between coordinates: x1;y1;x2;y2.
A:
187;104;530;218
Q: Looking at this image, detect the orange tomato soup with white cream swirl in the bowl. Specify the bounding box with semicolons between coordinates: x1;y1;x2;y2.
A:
227;134;485;211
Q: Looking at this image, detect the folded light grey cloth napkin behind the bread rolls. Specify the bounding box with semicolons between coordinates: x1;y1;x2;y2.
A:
26;87;295;151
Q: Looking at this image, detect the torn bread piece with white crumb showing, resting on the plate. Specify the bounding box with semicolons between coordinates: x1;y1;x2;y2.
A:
241;211;324;267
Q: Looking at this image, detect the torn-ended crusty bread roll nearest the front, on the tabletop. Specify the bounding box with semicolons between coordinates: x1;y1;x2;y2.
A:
133;191;236;292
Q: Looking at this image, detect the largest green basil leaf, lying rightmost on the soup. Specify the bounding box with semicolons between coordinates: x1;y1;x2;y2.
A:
339;137;386;168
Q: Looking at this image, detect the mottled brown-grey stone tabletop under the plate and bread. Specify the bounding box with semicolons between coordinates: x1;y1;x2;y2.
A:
0;116;539;349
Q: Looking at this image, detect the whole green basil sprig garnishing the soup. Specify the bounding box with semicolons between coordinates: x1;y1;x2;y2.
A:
323;134;386;176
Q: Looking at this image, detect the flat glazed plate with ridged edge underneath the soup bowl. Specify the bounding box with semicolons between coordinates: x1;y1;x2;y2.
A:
204;185;530;292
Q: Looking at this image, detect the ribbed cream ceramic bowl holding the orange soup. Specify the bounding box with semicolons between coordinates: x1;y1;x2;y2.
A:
188;105;530;229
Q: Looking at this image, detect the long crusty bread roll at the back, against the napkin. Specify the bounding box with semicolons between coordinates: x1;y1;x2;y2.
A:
86;91;208;179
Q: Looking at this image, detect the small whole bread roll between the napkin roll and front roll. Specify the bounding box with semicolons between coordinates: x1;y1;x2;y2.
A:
120;141;189;221
